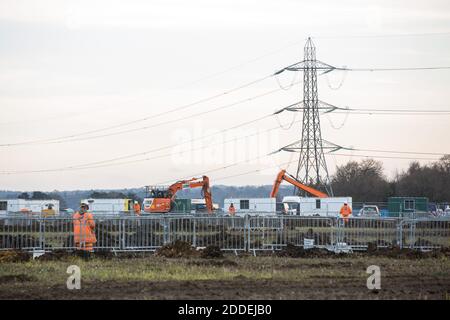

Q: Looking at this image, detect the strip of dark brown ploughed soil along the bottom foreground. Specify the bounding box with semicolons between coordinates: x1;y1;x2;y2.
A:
0;275;450;299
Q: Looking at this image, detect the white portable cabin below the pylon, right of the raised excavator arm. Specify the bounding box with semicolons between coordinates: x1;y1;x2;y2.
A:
283;196;352;217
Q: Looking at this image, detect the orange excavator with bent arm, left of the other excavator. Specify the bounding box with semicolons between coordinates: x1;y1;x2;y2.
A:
144;176;213;214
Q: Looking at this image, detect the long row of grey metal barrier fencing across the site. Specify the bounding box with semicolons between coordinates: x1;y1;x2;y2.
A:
0;215;450;252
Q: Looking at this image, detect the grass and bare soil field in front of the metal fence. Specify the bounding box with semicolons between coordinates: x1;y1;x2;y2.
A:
0;251;450;299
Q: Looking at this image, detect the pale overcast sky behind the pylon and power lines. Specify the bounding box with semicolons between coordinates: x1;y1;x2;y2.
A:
0;0;450;190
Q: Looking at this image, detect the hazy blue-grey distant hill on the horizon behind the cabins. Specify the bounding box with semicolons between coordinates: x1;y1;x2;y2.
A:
0;185;293;209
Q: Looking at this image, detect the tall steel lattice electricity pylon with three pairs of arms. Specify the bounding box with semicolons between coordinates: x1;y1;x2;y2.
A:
280;38;341;196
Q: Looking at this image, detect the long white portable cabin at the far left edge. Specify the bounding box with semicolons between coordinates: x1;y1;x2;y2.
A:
0;199;59;215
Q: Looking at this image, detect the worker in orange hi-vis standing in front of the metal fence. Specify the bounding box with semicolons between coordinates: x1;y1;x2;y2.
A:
73;203;97;252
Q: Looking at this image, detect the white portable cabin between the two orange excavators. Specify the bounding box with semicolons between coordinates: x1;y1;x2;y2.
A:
223;198;277;216
